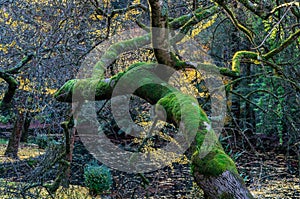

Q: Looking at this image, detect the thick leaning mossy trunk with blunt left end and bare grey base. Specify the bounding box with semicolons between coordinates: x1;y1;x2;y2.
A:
55;64;252;198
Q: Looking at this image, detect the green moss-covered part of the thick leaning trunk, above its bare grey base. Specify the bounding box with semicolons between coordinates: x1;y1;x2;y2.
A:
56;64;241;179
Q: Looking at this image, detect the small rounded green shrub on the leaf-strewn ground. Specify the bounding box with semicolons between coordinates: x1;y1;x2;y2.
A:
84;164;112;195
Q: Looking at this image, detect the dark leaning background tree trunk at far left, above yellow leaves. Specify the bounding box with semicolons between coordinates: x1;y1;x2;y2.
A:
5;111;25;158
